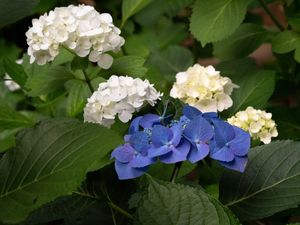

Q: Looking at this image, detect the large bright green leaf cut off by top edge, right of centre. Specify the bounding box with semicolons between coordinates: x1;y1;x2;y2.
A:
190;0;249;46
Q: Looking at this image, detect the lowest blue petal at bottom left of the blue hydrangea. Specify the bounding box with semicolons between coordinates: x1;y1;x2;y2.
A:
115;161;148;180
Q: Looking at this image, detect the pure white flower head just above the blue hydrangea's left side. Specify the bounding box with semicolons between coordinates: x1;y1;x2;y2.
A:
84;75;162;127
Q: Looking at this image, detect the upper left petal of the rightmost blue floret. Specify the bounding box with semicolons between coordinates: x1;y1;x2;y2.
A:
212;119;235;148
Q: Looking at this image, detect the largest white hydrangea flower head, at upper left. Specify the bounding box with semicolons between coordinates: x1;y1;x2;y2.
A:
26;5;125;69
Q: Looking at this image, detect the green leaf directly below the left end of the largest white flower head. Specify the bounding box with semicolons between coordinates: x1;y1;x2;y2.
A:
25;65;73;97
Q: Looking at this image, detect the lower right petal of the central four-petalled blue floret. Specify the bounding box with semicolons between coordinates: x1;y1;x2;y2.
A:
159;141;190;164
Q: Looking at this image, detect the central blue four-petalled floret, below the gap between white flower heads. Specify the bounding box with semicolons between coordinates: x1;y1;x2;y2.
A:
149;125;190;164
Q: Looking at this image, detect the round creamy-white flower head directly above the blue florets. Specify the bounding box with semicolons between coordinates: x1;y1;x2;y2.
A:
170;64;238;112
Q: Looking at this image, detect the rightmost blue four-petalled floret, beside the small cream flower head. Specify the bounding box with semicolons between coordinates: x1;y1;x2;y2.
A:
209;119;251;172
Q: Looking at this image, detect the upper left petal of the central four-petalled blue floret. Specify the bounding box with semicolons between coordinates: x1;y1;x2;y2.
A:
151;125;173;147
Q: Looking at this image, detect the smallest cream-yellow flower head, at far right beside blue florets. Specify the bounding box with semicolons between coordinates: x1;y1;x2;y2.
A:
228;106;278;144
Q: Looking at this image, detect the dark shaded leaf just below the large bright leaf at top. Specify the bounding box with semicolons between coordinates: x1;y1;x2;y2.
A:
213;23;268;60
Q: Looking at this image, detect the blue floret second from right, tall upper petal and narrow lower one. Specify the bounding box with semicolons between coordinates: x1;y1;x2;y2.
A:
183;115;214;163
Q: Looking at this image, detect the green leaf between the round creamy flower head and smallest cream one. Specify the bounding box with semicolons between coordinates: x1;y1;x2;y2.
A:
228;70;275;115
